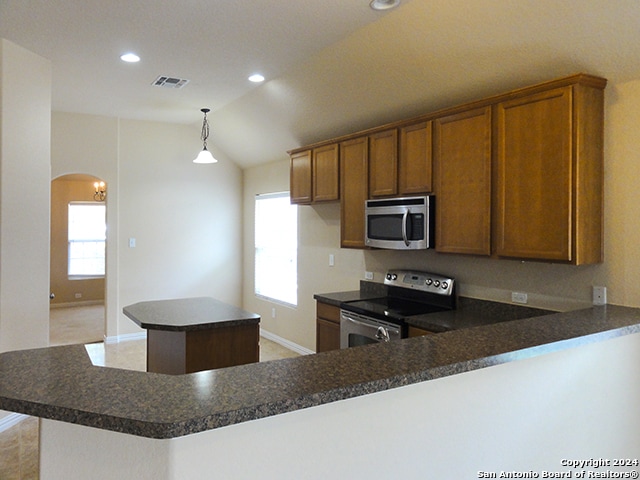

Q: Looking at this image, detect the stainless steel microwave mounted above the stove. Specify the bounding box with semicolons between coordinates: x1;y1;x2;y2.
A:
364;195;435;250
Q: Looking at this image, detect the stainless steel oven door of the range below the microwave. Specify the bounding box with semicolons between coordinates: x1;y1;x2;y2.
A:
340;310;402;348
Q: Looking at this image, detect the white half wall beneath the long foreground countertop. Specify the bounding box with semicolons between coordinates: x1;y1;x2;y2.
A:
40;334;640;480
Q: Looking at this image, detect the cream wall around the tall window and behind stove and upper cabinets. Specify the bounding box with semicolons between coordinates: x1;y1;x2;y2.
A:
244;80;640;349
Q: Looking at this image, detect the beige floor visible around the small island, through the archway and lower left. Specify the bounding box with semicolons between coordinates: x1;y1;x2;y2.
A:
0;305;298;480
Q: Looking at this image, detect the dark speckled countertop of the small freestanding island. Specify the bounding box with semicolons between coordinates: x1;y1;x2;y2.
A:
122;297;260;332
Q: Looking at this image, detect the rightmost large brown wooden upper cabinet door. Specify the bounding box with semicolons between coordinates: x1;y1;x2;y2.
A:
496;87;573;261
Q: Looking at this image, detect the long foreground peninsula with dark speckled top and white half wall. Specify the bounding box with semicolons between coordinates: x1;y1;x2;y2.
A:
0;306;640;479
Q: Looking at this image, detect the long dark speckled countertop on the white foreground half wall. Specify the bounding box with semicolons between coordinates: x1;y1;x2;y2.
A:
0;306;640;438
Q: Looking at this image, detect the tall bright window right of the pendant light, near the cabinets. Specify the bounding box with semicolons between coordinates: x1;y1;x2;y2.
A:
255;192;298;305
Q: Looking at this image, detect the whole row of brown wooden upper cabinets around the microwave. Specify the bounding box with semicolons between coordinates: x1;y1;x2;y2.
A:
290;74;607;265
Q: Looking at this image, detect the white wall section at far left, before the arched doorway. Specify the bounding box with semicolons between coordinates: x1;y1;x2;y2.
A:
0;39;51;352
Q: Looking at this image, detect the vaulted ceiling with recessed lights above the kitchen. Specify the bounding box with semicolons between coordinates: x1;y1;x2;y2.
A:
0;0;640;167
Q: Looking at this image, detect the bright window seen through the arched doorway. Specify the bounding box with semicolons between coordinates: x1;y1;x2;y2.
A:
68;202;107;277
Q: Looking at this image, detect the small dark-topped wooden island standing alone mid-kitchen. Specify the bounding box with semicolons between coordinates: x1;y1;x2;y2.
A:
123;297;260;375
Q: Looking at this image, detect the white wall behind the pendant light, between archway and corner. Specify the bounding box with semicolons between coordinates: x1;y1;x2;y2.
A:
118;120;242;331
